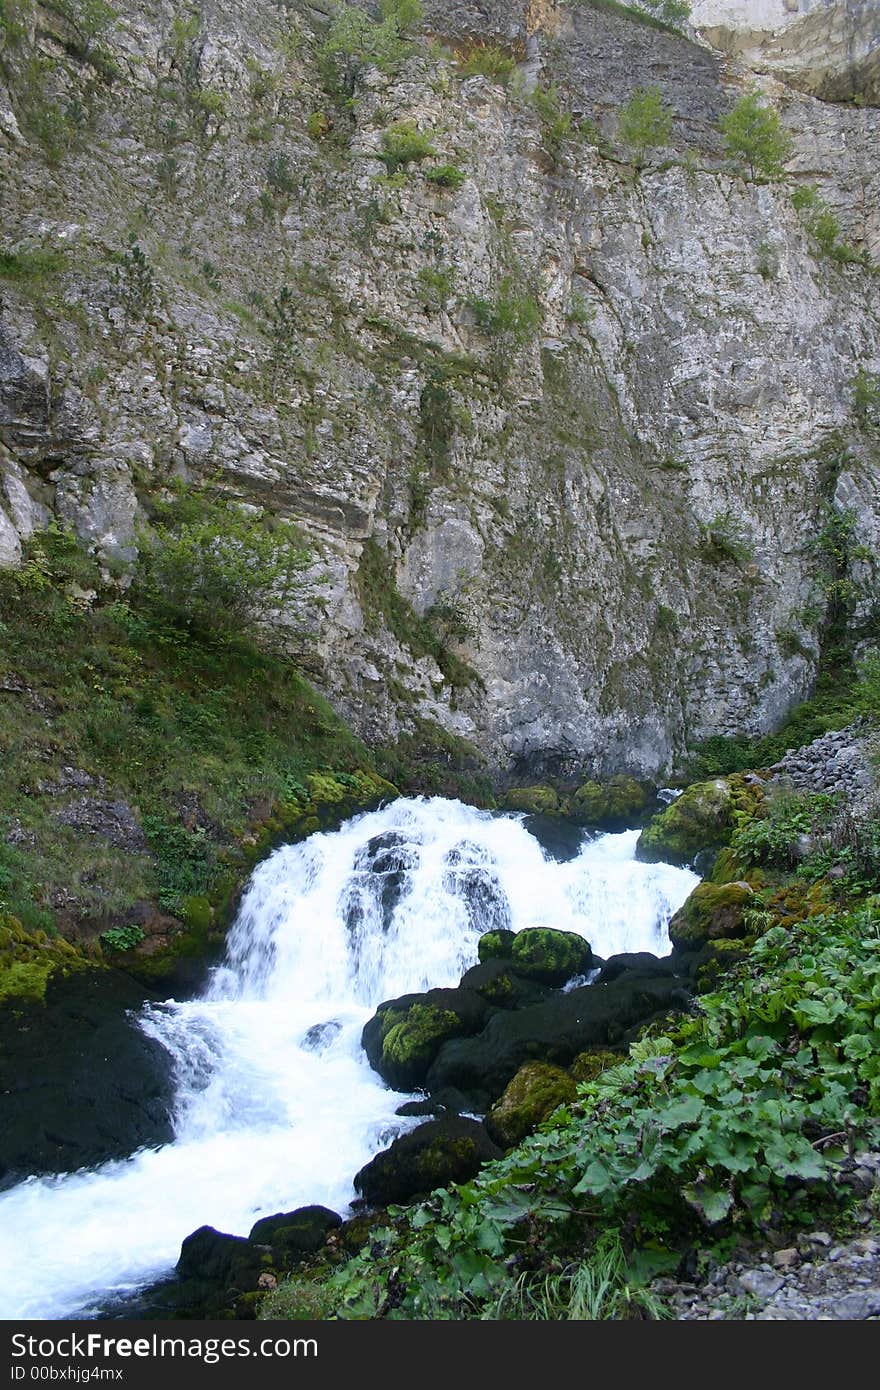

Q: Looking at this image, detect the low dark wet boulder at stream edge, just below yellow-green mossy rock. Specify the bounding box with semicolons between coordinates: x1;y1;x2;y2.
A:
355;1118;500;1207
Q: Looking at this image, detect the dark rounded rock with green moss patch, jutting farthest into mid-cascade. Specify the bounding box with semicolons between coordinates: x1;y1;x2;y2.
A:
361;990;489;1091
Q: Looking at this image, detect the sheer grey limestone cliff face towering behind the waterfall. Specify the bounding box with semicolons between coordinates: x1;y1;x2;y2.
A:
0;0;880;776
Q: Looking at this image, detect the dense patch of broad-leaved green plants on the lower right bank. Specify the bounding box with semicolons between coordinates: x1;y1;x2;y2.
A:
314;901;880;1319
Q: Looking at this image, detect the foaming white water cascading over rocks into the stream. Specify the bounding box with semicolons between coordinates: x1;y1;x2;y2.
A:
0;798;698;1319
